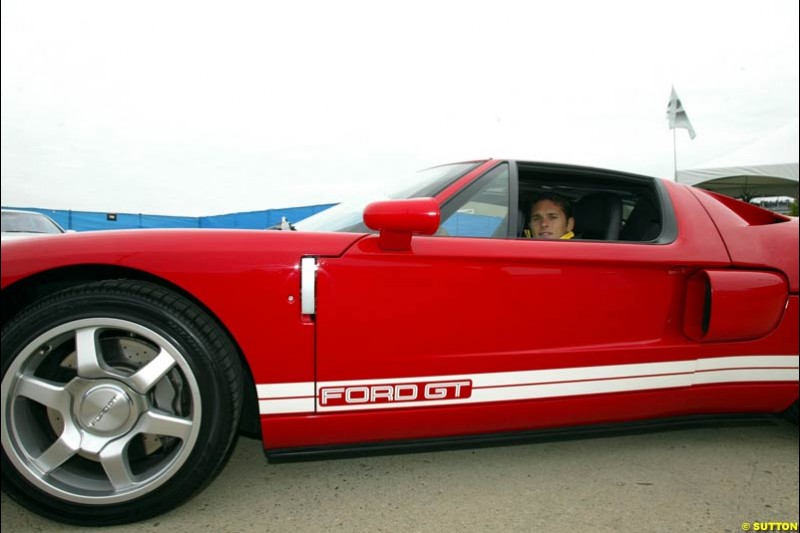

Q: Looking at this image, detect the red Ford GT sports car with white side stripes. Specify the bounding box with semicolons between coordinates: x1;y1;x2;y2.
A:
2;160;800;525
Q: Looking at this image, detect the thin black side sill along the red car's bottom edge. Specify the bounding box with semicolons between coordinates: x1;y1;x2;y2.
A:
264;413;780;463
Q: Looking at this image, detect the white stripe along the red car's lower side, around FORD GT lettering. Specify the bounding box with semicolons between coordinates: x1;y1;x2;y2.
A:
257;355;800;415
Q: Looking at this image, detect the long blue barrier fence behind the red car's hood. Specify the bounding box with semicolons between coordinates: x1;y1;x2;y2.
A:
3;204;336;231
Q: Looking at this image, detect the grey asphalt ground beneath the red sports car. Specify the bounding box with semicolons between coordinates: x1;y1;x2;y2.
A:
1;421;798;533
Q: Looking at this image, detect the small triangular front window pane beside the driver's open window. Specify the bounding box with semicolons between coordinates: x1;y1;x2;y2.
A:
437;164;509;238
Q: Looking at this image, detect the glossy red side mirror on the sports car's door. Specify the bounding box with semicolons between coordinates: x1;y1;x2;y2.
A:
364;198;441;251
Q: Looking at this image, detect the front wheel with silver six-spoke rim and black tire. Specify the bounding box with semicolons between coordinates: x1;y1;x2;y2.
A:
2;280;243;526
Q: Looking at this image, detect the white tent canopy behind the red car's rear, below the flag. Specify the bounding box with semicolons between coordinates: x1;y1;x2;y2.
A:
677;118;800;198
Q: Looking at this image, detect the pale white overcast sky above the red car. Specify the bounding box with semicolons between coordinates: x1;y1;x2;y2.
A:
1;0;800;216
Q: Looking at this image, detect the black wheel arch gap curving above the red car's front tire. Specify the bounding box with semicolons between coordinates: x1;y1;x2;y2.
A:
0;265;261;439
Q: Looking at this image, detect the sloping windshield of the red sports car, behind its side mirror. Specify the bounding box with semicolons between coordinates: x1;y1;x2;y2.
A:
295;161;481;232
